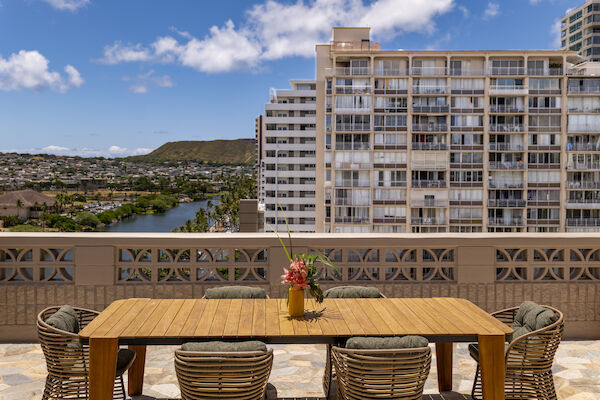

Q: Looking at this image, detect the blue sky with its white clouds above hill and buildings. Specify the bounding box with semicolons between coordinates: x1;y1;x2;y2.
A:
0;0;583;157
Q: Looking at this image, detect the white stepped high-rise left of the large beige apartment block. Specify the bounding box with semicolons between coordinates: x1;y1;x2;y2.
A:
256;80;316;232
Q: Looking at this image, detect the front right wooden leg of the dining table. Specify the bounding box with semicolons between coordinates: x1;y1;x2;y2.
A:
479;335;506;400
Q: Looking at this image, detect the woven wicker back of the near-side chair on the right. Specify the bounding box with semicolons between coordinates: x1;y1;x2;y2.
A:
332;347;431;400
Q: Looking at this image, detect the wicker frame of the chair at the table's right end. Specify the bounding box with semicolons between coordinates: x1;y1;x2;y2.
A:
470;306;564;400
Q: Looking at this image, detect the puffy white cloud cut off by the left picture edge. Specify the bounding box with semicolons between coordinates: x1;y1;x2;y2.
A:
0;50;83;93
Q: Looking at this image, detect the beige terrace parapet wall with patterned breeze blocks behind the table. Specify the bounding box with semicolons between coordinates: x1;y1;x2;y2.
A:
0;233;600;343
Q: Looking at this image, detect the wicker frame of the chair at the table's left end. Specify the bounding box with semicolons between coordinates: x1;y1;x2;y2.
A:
37;307;135;400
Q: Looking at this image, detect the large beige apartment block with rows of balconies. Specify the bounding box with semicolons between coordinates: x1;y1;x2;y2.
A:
316;28;600;232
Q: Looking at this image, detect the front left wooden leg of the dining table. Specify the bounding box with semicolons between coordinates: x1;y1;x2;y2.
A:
88;338;119;400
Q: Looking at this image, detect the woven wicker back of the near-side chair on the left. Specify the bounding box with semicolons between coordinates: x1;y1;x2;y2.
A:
175;349;273;400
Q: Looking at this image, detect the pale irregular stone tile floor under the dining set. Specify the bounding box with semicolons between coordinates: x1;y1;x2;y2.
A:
0;341;600;400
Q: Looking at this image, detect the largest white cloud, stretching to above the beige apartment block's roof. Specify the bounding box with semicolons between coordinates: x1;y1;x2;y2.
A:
101;0;454;73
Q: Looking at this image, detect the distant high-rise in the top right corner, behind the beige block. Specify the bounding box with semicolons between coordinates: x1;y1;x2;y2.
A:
560;0;600;61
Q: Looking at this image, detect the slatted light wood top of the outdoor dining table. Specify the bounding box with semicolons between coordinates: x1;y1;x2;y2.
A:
79;297;512;344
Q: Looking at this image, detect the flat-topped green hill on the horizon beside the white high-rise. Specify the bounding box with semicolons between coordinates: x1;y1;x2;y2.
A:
126;139;256;164
